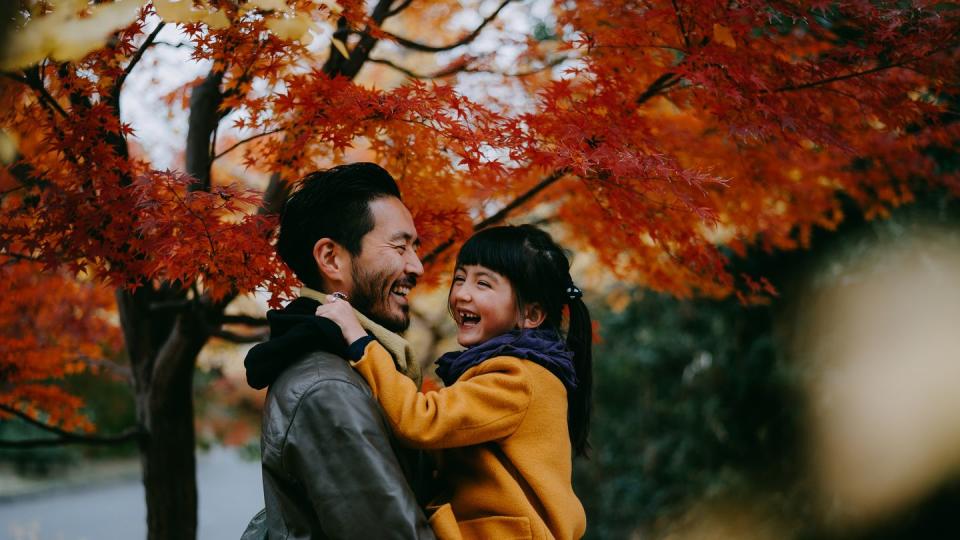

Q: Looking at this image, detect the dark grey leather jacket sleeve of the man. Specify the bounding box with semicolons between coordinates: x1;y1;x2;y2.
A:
282;380;434;539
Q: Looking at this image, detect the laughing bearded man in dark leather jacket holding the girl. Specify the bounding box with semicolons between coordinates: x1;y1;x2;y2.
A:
244;163;433;539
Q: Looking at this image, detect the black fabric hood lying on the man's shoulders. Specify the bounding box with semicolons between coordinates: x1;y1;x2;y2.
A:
243;297;347;390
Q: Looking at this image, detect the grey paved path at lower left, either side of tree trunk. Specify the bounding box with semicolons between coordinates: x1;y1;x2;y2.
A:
0;449;263;540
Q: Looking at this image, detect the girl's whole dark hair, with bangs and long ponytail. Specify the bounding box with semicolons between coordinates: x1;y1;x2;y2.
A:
457;225;593;456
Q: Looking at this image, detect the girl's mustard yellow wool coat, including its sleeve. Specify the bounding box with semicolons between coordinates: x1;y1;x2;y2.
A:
353;341;587;540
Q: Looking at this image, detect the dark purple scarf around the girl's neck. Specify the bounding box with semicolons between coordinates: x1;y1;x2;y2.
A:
437;328;577;391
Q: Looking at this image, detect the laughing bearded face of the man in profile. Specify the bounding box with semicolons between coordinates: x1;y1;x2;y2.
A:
348;197;423;332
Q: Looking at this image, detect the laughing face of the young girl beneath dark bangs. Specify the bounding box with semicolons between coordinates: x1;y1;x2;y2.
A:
447;265;520;347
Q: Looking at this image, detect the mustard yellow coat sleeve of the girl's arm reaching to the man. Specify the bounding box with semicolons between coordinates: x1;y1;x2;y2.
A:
353;341;531;449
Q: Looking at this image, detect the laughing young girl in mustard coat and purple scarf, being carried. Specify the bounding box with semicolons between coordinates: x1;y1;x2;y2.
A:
317;225;592;539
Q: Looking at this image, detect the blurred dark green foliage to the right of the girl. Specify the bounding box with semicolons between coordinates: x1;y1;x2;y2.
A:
574;184;960;540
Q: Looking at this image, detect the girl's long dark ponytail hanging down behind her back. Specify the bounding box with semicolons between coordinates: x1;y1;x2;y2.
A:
567;295;593;456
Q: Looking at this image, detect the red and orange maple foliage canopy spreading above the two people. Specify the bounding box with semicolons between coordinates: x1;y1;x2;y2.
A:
0;0;960;442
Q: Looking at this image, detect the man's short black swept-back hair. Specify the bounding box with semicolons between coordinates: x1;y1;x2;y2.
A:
277;163;400;289
